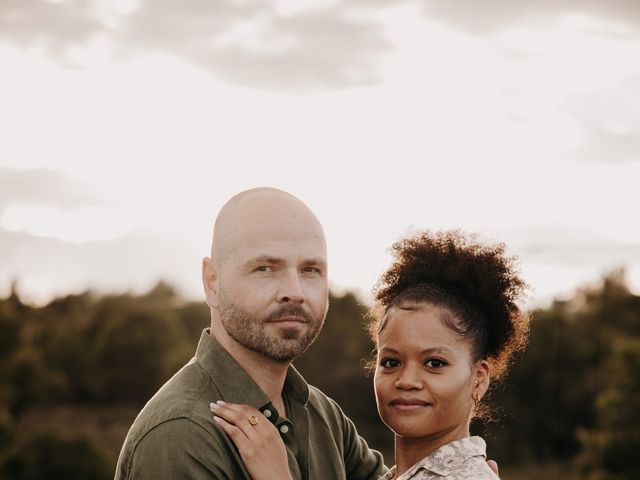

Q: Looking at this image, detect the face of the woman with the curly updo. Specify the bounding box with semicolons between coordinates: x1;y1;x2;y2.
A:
374;304;488;444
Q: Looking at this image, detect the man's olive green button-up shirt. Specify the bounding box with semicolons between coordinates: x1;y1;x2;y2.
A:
115;330;386;480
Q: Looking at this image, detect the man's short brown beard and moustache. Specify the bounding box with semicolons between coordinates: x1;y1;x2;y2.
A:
219;292;325;363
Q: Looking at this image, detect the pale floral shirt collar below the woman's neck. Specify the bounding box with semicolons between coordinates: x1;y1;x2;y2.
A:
383;437;487;480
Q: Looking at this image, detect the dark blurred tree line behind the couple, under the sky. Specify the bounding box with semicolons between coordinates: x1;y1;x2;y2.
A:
0;271;640;480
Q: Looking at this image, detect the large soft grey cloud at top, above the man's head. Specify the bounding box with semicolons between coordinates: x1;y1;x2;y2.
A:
122;0;388;89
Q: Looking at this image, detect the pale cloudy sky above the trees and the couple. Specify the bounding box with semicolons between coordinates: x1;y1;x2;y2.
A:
0;0;640;305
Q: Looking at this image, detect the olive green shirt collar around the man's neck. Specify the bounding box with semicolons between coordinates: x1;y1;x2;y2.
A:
195;328;309;410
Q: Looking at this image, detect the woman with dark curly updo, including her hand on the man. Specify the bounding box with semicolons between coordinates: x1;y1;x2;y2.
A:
214;231;528;480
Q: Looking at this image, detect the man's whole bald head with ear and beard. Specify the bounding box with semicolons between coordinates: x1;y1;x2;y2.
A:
202;188;329;364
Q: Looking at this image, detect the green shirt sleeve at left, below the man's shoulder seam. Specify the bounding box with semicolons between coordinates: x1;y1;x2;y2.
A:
127;418;237;480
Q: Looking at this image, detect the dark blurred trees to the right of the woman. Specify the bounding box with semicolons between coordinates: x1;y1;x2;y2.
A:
489;272;640;472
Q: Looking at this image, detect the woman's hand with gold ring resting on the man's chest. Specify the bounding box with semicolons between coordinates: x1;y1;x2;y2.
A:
209;400;292;480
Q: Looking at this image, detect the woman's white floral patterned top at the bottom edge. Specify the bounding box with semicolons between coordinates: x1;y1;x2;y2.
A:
379;437;499;480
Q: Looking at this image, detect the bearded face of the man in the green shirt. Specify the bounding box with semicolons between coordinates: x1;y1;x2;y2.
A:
212;197;328;362
